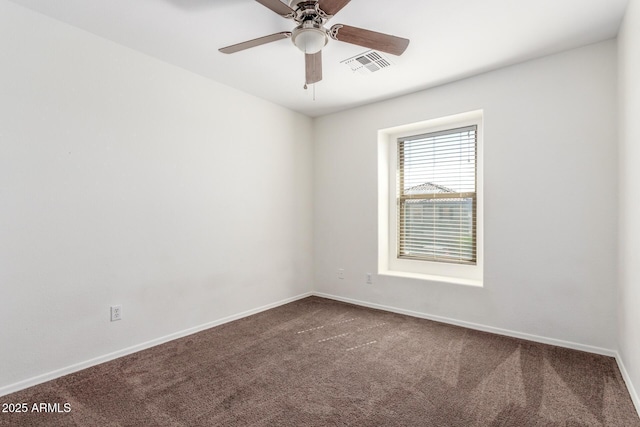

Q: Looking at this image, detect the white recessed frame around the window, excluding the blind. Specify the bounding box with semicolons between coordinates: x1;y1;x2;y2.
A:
378;110;484;286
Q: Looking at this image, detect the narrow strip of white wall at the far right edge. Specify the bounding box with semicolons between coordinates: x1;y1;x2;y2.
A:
618;0;640;411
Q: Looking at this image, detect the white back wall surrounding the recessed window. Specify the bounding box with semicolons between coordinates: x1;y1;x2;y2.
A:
314;41;618;351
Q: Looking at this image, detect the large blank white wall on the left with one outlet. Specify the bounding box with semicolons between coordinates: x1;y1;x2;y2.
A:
0;0;313;394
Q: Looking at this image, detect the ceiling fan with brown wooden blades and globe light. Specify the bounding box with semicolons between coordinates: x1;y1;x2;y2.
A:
219;0;409;88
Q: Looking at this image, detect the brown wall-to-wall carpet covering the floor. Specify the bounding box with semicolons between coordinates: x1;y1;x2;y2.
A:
0;297;640;427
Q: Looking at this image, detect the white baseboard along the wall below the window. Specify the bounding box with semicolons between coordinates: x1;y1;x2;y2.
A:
313;292;617;357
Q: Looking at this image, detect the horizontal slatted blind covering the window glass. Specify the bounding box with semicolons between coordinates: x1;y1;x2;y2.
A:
398;126;477;264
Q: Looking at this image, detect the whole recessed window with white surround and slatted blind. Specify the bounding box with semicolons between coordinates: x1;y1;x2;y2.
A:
378;111;483;286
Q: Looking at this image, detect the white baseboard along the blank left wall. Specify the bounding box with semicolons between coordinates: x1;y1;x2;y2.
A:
0;292;313;396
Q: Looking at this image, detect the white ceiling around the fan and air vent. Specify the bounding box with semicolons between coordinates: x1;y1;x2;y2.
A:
11;0;628;116
